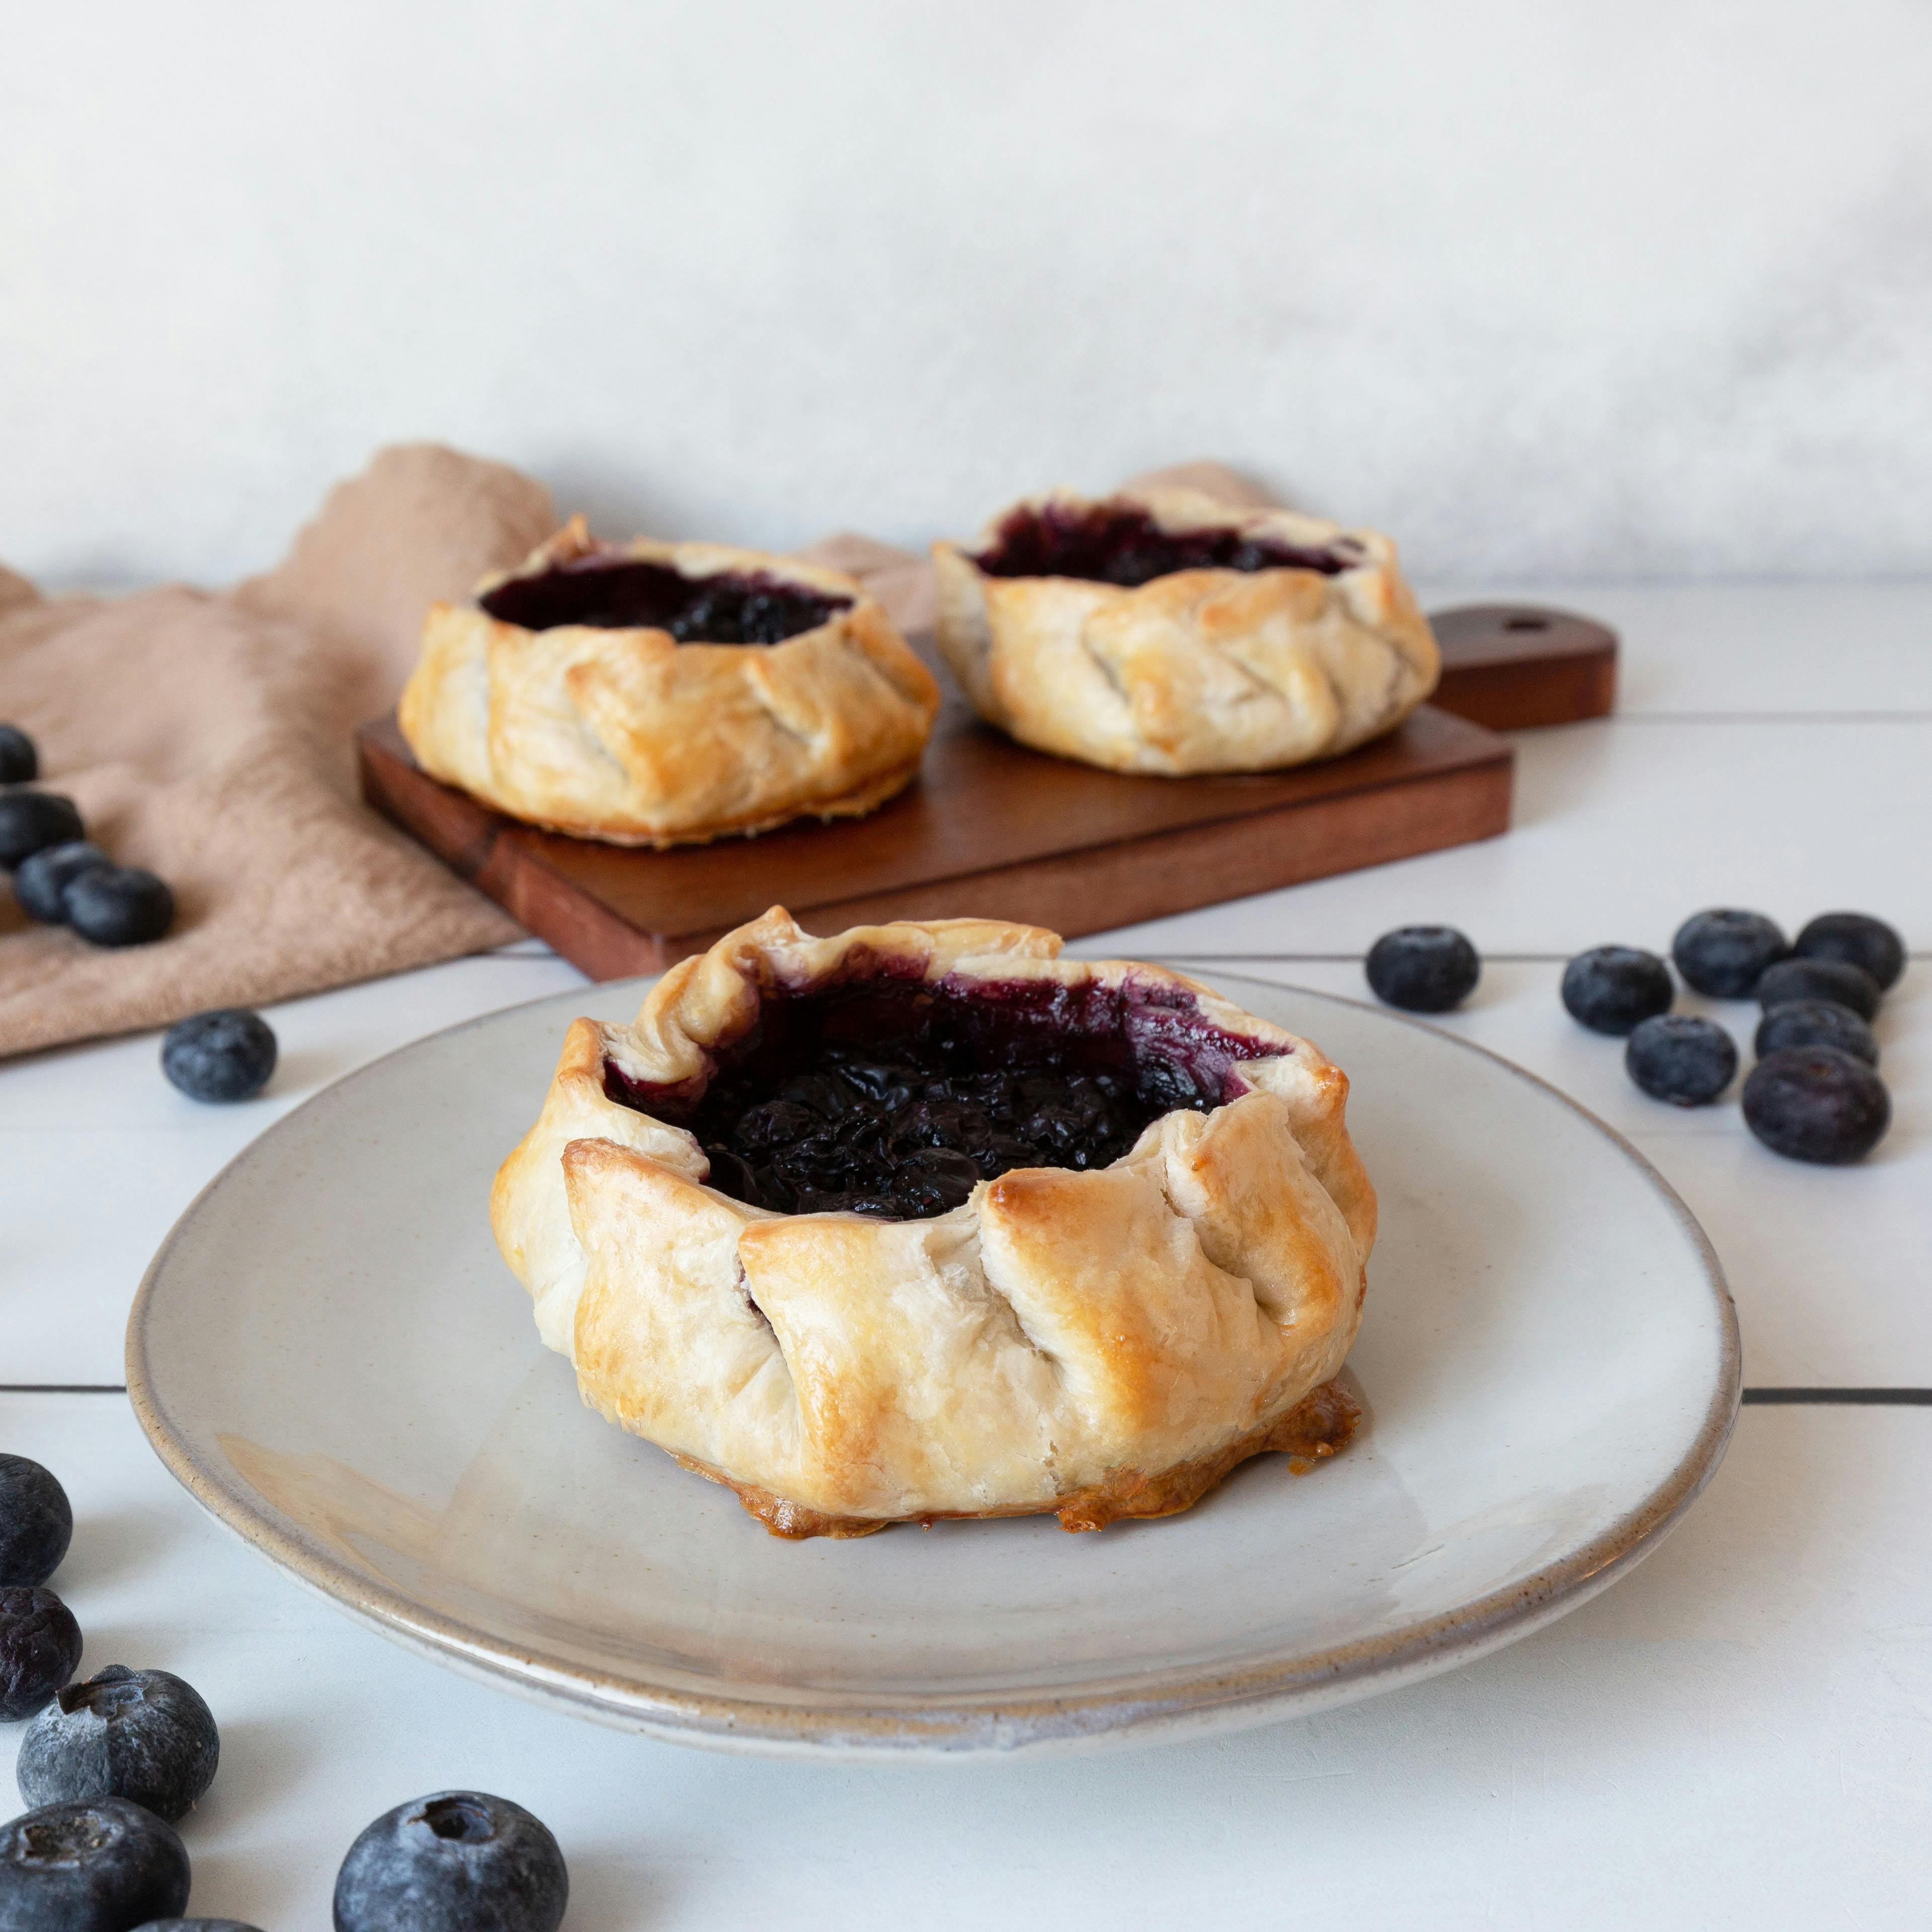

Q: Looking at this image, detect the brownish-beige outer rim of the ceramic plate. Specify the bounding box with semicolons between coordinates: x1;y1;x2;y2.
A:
127;974;1743;1760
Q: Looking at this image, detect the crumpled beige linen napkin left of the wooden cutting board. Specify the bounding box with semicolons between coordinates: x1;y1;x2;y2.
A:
0;446;556;1055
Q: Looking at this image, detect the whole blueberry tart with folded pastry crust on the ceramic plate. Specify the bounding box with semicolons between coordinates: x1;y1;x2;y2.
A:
491;908;1376;1536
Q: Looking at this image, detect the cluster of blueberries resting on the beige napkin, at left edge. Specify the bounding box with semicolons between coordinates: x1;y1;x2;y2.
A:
0;725;174;947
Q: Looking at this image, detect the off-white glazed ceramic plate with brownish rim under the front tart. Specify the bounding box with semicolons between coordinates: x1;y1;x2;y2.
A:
127;976;1739;1758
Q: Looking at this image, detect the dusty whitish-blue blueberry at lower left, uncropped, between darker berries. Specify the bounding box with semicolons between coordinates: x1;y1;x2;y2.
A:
16;1663;222;1824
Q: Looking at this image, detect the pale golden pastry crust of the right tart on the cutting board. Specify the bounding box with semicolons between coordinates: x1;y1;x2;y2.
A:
933;489;1439;777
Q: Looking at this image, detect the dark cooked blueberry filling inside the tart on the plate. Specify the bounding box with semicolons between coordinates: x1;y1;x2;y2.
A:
690;1035;1219;1221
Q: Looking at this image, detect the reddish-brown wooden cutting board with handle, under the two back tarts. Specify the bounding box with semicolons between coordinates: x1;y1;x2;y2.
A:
357;605;1617;980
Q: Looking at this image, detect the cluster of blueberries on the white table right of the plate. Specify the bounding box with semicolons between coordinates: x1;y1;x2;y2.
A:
1563;906;1905;1165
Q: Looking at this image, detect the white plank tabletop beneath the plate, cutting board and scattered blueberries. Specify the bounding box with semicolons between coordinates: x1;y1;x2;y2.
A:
0;584;1932;1932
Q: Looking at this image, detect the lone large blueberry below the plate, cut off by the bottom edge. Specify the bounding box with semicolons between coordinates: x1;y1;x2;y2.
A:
336;1791;570;1932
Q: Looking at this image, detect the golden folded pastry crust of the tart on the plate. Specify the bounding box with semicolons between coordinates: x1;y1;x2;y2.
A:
491;908;1376;1536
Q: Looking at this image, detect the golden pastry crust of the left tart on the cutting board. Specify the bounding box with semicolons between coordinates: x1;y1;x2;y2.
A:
398;518;939;846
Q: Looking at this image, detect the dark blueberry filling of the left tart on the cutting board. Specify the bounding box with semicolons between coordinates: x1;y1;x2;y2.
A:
481;556;852;643
